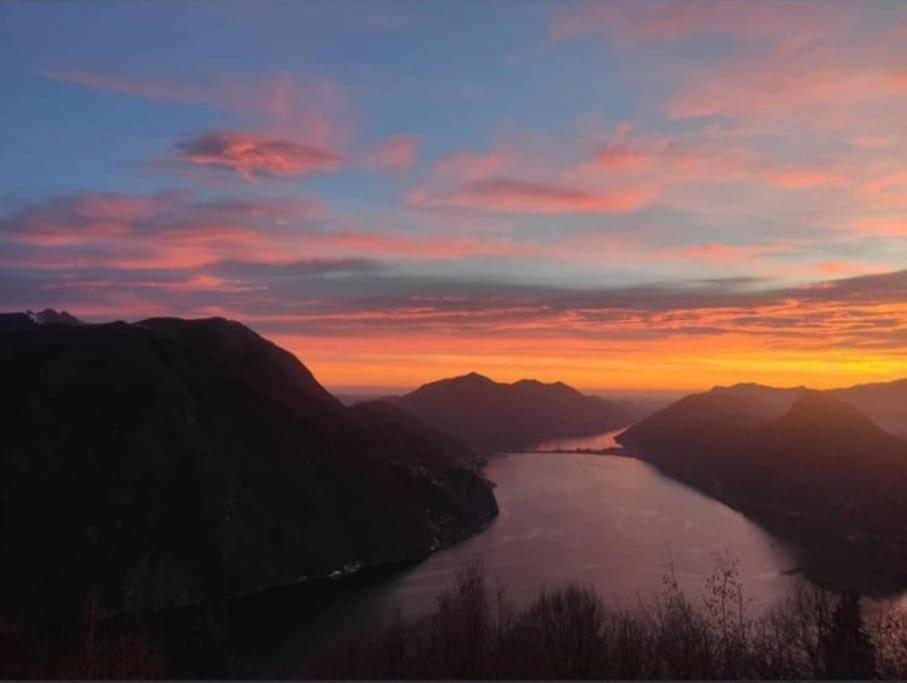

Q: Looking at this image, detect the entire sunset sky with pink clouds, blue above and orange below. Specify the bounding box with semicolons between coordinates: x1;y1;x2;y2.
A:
0;0;907;391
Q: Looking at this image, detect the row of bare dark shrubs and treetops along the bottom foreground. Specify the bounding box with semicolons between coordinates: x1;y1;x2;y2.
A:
310;557;907;679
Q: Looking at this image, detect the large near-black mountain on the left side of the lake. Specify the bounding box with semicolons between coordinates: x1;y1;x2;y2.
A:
0;316;497;621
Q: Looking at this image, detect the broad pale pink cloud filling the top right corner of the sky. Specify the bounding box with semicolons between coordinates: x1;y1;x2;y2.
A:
616;2;907;134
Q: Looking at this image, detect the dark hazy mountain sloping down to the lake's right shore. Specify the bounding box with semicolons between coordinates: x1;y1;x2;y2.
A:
618;390;907;591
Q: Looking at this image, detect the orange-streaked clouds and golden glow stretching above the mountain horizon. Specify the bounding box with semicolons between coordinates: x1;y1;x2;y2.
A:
250;272;907;389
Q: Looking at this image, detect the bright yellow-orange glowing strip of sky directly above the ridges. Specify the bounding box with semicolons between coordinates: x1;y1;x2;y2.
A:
272;336;907;392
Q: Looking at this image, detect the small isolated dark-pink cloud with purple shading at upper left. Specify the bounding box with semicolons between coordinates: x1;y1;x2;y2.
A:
177;131;343;181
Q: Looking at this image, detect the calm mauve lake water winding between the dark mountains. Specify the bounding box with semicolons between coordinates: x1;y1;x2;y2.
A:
266;433;797;673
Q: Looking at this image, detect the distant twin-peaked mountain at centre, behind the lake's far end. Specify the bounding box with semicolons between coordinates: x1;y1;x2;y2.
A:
397;373;633;454
